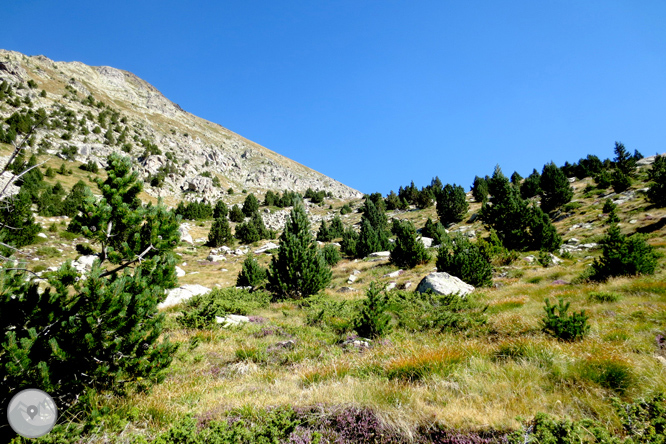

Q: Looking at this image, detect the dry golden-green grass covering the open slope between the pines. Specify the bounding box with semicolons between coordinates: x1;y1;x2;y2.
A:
18;160;666;438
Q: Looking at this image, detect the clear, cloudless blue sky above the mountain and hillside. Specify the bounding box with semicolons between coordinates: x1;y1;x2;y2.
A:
0;0;666;194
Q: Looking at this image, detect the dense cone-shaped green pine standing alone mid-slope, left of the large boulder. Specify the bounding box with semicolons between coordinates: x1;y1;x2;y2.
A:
268;204;331;299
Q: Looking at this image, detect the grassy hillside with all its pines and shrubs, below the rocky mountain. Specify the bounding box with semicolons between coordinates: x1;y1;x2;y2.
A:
0;63;666;443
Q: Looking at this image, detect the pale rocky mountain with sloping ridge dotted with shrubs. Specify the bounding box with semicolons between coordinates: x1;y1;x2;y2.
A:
0;50;362;199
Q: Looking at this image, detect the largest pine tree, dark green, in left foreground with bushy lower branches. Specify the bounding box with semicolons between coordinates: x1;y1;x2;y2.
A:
0;154;180;426
